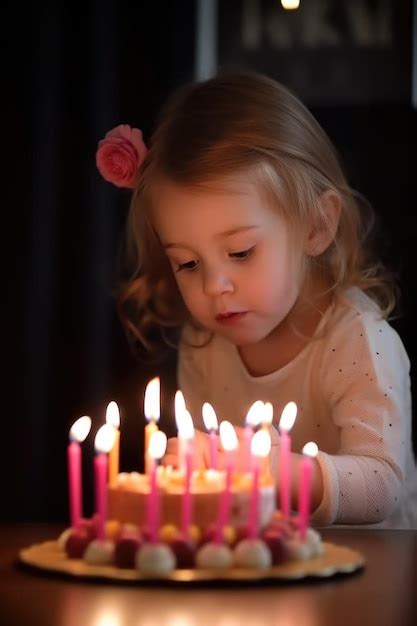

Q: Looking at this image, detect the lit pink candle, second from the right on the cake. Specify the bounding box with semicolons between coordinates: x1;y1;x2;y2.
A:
278;402;297;517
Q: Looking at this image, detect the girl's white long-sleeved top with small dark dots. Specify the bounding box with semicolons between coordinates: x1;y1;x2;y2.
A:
178;288;417;528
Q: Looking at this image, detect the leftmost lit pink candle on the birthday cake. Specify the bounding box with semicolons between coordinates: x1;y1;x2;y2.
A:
67;415;91;528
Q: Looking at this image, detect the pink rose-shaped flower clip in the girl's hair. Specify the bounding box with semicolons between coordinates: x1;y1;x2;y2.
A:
96;124;148;189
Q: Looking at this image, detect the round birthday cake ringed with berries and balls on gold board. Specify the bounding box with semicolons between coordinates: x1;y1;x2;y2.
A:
21;388;363;582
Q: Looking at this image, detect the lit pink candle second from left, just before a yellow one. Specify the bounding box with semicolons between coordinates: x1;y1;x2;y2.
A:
94;424;116;541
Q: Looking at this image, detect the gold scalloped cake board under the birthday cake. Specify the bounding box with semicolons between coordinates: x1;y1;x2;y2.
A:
19;541;365;584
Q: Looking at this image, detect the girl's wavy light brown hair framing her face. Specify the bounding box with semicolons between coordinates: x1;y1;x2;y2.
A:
119;73;395;349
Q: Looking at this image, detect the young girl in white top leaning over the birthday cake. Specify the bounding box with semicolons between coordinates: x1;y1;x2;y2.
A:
97;74;417;528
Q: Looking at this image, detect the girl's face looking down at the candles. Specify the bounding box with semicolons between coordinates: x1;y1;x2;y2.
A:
152;176;301;346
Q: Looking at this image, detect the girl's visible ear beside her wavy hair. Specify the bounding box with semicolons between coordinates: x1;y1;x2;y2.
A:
305;190;342;256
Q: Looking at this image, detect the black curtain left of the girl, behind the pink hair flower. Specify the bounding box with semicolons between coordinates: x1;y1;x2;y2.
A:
0;0;194;520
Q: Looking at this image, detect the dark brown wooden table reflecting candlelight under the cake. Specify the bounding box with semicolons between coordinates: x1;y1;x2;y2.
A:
0;524;417;626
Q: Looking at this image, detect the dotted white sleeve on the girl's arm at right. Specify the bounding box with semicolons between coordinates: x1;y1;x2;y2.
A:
313;312;411;524
